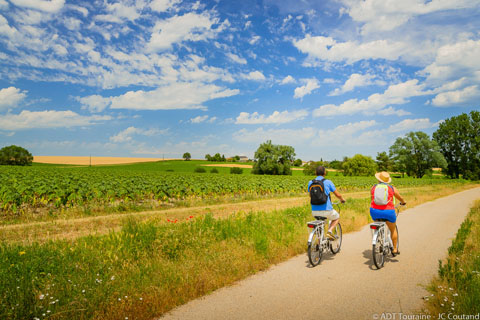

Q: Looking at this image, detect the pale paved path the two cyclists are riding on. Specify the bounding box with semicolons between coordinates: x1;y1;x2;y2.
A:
162;188;480;320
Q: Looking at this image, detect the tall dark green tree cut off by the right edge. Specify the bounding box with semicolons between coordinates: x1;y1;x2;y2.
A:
433;111;480;180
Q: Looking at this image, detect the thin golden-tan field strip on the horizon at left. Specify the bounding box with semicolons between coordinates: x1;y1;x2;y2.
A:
33;156;174;166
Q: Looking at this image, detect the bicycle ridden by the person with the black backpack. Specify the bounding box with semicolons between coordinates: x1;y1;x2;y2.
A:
307;202;342;267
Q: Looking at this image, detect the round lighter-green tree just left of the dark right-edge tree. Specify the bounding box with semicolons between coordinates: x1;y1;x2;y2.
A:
390;131;447;178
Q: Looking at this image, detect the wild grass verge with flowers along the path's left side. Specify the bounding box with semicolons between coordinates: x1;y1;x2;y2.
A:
0;187;476;319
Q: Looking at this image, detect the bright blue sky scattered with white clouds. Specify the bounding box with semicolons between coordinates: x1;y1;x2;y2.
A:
0;0;480;161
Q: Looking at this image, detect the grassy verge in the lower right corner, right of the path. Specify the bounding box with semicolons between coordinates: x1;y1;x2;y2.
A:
424;201;480;319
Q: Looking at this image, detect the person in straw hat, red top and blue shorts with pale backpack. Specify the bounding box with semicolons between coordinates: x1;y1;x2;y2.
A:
370;171;407;255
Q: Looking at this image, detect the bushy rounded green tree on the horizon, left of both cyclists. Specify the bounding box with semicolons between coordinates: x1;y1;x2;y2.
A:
252;140;295;175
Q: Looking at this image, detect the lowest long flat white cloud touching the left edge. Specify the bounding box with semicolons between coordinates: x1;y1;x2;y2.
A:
0;110;111;131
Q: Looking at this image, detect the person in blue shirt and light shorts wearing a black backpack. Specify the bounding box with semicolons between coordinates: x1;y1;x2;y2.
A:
308;166;345;240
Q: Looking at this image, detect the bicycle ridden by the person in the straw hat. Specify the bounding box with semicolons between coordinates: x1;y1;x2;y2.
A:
370;204;403;269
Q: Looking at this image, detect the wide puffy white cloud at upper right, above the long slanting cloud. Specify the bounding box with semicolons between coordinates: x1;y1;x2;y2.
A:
293;35;409;66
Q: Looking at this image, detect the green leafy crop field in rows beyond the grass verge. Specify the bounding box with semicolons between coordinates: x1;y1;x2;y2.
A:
0;161;465;222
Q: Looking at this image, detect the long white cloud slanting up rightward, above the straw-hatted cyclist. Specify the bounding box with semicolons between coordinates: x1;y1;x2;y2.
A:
313;79;431;117
